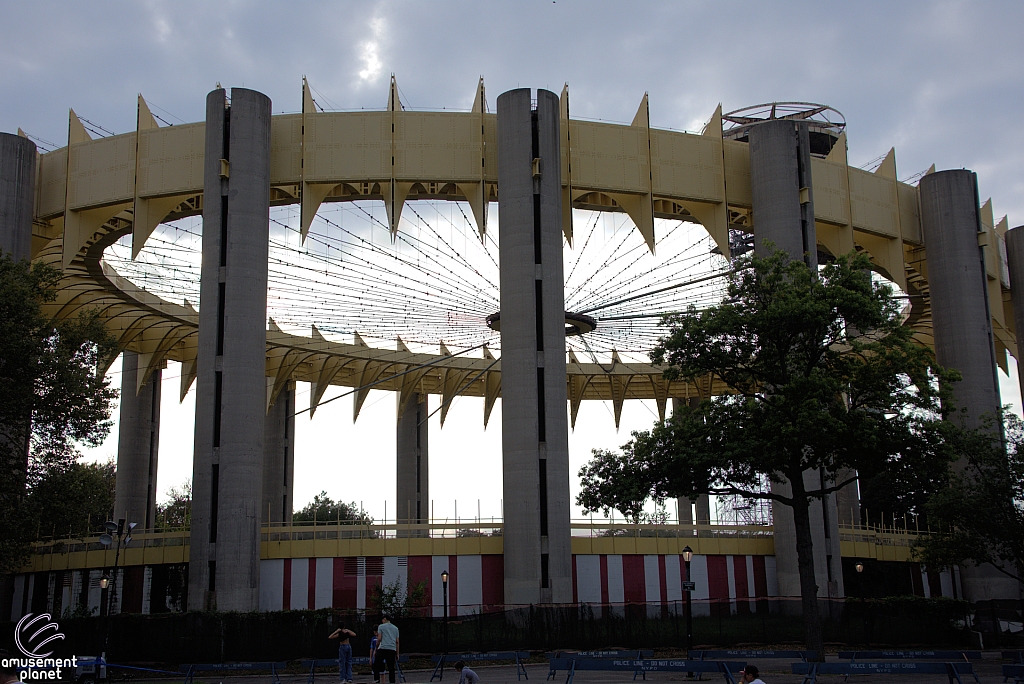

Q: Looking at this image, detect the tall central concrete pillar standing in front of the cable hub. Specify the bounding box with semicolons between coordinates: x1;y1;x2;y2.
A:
498;88;572;604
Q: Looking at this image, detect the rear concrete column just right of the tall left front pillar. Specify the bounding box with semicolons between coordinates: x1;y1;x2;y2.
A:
260;383;295;525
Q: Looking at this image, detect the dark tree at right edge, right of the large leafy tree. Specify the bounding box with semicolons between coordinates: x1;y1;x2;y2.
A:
918;414;1024;582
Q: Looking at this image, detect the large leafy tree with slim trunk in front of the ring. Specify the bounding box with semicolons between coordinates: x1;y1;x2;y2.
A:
580;253;956;653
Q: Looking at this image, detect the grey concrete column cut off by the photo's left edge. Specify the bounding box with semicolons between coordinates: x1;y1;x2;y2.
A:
0;133;36;259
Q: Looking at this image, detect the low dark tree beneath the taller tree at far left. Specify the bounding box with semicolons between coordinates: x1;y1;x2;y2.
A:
25;460;115;537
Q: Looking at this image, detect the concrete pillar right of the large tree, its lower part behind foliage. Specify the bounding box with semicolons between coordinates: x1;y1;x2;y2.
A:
918;174;1021;602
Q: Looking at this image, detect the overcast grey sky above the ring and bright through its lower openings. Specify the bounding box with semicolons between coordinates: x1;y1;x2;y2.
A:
0;0;1024;518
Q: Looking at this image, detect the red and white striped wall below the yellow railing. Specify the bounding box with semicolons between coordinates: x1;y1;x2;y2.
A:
260;554;778;616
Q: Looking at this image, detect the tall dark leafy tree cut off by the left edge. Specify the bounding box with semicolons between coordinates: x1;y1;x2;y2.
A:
0;255;117;573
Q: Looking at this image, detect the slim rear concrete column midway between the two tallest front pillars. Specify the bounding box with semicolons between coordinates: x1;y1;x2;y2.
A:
394;394;430;537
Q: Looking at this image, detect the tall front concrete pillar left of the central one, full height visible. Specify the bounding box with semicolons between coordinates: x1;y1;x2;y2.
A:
188;88;270;611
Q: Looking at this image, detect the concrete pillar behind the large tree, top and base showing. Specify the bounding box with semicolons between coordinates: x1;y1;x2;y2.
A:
750;120;844;598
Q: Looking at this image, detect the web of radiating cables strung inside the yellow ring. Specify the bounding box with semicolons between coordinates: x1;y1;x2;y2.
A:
104;201;729;362
